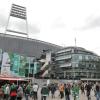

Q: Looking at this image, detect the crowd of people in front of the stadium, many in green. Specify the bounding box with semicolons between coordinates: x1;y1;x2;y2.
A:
0;82;100;100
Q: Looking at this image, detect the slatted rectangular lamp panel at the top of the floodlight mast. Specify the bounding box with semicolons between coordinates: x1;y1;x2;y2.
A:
10;4;26;19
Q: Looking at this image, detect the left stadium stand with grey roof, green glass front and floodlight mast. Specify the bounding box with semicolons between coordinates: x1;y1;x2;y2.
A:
0;4;62;77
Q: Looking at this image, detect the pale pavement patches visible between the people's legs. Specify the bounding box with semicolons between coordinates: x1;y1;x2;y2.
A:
23;90;96;100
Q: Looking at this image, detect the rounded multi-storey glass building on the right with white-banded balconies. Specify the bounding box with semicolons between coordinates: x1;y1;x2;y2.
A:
55;47;100;79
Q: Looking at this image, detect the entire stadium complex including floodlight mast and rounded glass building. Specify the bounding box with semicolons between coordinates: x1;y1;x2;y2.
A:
0;4;100;79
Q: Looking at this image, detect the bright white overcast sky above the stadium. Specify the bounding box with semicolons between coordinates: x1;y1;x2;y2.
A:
0;0;100;55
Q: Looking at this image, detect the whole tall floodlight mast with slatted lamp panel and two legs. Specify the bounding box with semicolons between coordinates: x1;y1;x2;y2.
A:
5;4;28;38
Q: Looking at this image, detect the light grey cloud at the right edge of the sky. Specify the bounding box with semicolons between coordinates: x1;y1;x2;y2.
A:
78;16;100;30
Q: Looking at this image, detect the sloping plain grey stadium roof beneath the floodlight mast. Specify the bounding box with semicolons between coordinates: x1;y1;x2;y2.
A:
0;33;63;57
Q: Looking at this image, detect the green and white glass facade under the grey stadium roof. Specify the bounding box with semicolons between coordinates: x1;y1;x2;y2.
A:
0;49;40;77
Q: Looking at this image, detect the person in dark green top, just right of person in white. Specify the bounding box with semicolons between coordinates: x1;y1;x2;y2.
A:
41;84;49;100
